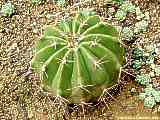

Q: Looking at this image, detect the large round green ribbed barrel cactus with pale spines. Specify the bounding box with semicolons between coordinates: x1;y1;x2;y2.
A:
31;13;124;103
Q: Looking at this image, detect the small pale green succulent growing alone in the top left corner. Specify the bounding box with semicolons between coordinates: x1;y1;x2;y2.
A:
1;2;15;16
